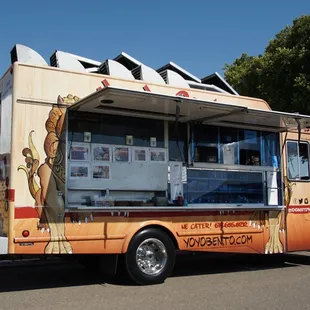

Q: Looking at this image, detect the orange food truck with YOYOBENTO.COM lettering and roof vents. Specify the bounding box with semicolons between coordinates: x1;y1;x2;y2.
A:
0;45;310;285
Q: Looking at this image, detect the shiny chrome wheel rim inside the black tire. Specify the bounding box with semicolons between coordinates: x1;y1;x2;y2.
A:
136;238;168;276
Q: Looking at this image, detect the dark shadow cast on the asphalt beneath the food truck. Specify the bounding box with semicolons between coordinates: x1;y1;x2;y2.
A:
0;252;310;292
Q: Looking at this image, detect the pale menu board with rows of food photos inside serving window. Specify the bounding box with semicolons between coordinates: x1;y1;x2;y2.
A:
68;143;168;191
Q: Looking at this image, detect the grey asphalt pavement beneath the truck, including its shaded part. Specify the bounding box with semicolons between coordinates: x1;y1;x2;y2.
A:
0;252;310;310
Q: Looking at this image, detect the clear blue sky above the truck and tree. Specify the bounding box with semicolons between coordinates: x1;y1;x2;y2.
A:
0;0;310;78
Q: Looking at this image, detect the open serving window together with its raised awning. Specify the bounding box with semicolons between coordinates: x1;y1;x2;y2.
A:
67;87;310;208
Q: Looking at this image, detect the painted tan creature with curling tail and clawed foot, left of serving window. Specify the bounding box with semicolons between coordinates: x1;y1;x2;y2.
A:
18;95;80;254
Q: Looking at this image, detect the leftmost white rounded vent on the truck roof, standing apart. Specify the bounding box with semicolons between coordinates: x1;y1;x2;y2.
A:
11;44;48;66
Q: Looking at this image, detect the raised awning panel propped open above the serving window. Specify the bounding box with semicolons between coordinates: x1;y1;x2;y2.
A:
69;86;310;132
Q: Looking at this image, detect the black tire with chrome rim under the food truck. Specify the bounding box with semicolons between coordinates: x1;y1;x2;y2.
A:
125;228;175;285
